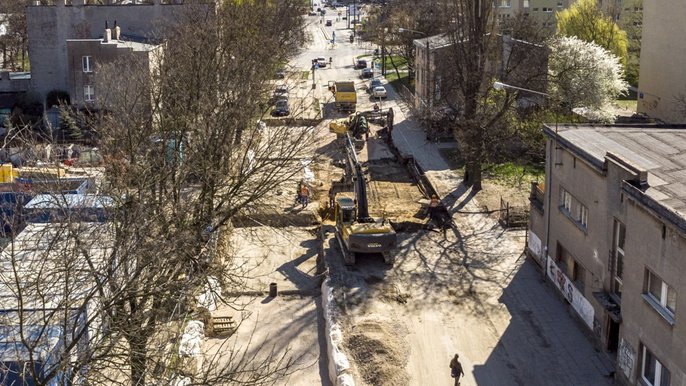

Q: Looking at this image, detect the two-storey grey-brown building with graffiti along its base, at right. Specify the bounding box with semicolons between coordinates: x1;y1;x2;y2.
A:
527;125;686;386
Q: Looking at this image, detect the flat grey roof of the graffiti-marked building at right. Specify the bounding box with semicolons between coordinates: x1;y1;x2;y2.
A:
545;124;686;232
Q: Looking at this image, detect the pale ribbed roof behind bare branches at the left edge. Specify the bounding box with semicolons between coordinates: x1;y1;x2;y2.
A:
0;223;112;310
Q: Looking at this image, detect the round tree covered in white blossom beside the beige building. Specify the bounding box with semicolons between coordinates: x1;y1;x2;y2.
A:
548;36;629;122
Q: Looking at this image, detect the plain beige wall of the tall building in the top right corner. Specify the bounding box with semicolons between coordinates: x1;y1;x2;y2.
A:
637;0;686;123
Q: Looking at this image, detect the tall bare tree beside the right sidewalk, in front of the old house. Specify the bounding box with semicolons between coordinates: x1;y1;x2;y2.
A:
435;0;546;190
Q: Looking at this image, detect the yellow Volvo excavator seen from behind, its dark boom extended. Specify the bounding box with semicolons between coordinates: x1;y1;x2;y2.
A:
332;132;397;265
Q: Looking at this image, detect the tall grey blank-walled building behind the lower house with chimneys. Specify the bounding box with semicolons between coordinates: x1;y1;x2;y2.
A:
26;0;208;105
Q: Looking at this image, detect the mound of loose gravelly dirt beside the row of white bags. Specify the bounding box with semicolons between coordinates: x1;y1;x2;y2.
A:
345;320;409;386
